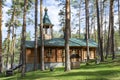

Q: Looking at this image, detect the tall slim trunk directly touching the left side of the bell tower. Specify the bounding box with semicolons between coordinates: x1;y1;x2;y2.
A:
40;0;44;71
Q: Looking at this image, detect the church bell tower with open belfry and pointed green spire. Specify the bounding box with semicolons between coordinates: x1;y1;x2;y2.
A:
43;8;53;39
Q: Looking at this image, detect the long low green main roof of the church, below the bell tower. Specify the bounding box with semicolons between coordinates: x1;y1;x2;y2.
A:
26;38;97;48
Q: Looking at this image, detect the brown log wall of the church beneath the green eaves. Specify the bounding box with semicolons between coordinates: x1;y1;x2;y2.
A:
26;48;96;64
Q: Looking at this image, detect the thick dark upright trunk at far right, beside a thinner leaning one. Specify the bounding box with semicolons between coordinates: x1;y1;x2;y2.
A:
110;0;115;60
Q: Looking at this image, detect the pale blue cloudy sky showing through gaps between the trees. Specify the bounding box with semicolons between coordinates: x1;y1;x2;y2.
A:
2;0;118;40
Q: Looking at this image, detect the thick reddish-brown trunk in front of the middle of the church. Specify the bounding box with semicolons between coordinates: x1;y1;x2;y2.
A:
65;0;71;71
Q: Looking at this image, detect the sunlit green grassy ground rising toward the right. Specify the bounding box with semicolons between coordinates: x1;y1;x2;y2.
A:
0;56;120;80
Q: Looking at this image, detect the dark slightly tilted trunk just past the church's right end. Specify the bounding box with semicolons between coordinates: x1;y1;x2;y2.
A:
96;0;104;61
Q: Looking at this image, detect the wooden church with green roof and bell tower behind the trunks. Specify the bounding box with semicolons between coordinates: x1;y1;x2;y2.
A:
26;9;97;71
